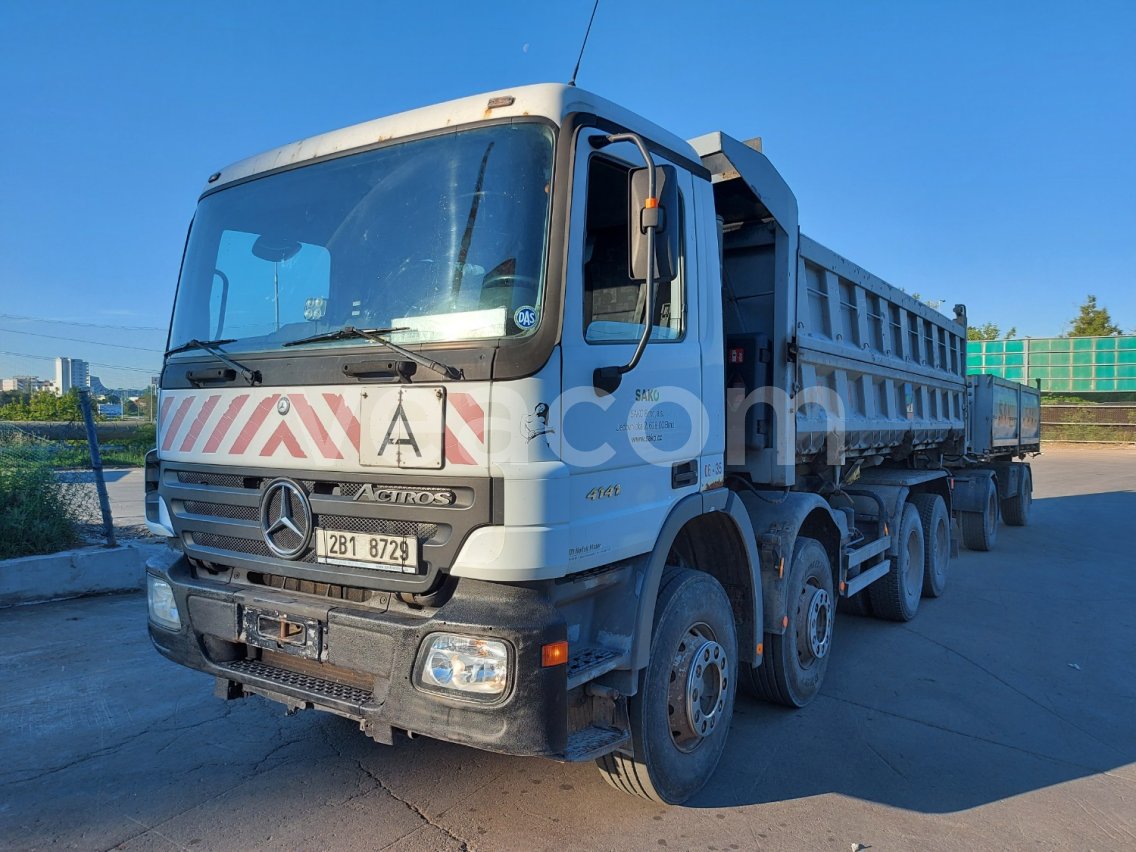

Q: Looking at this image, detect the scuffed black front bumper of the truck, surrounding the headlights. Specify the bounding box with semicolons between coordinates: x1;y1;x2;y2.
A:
147;552;568;757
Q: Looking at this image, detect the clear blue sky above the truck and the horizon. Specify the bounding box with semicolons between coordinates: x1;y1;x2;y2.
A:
0;0;1136;386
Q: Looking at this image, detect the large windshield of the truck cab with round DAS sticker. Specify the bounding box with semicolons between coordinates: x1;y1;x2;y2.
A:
169;123;552;351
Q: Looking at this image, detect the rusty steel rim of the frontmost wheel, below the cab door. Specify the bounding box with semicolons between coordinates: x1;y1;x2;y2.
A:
667;623;729;752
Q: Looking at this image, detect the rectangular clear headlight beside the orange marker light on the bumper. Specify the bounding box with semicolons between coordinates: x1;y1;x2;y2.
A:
417;633;509;701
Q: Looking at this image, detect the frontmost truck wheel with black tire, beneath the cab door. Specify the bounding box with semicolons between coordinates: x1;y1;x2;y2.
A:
595;568;737;804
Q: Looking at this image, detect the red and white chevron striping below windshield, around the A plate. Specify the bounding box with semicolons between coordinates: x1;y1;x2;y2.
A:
158;389;487;468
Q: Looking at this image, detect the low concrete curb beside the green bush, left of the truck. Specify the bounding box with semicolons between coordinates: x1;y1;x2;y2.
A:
0;543;166;608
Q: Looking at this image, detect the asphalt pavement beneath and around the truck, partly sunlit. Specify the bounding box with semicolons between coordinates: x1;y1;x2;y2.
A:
0;449;1136;852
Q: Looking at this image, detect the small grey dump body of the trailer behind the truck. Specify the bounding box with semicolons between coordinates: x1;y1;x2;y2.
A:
967;375;1042;458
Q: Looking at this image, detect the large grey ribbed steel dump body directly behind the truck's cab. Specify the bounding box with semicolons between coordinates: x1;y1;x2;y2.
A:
692;133;966;485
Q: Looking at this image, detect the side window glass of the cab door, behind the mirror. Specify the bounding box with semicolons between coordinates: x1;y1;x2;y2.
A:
584;156;683;343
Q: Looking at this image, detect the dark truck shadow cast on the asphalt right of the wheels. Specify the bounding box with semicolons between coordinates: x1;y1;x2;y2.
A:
691;492;1136;812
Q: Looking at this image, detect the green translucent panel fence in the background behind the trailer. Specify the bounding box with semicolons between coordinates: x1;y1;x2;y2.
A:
967;334;1136;394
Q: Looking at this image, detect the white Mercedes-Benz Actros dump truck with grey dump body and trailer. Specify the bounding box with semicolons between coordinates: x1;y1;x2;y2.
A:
147;85;1037;803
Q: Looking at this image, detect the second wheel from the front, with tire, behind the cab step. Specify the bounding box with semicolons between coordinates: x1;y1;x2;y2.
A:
742;537;836;707
